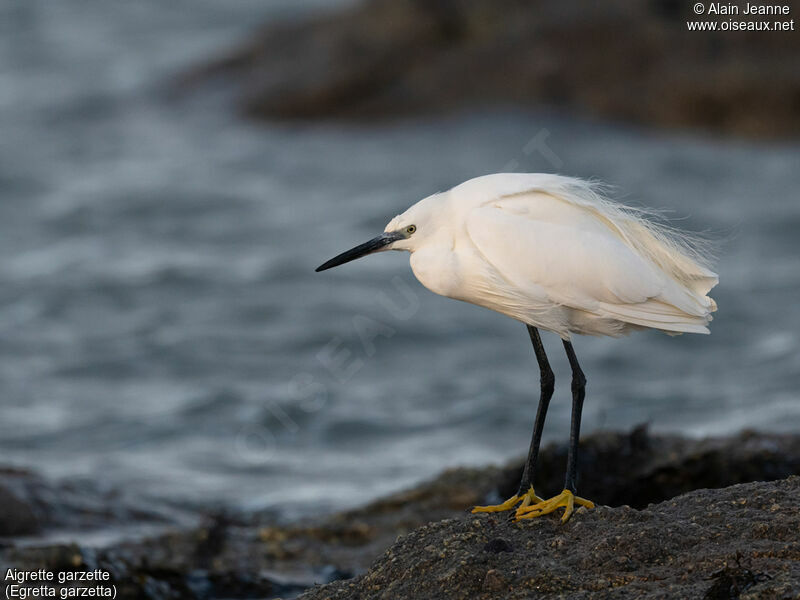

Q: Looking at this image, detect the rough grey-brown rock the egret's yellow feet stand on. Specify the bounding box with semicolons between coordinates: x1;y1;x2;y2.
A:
302;477;800;600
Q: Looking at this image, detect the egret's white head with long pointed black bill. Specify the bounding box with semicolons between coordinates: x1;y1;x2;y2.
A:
316;194;440;272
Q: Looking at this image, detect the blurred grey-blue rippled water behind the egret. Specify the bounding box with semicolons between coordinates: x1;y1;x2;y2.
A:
0;0;800;515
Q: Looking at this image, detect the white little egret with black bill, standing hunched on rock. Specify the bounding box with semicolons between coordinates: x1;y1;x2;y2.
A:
316;173;718;522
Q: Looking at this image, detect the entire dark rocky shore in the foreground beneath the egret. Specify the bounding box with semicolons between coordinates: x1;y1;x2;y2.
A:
0;428;800;599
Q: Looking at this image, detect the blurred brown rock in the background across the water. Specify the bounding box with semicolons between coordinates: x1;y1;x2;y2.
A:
179;0;800;137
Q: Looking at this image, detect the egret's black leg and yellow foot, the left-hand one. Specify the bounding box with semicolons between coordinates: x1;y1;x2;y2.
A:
472;325;556;513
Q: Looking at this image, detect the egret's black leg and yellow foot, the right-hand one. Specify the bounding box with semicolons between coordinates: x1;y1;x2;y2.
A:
515;340;594;523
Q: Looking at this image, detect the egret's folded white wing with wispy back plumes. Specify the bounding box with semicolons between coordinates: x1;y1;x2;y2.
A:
465;176;717;336
